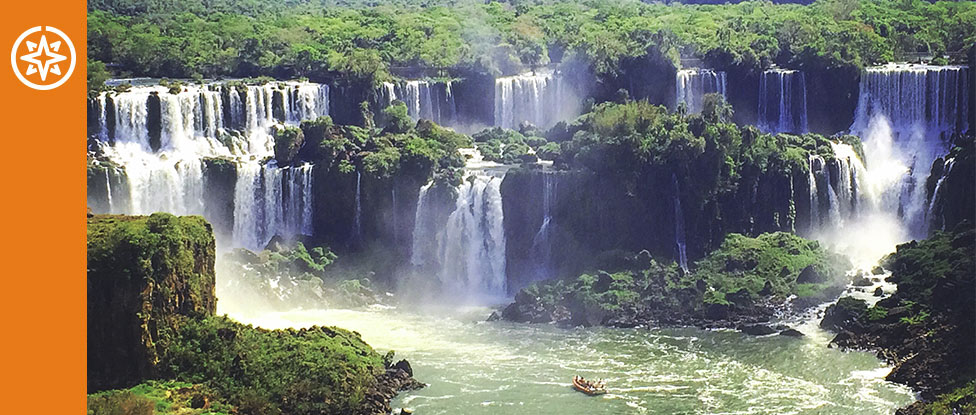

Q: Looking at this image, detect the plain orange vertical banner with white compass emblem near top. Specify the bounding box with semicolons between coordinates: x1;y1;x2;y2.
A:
0;0;87;414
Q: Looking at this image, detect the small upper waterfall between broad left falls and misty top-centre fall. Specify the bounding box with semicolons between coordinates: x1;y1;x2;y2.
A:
377;80;457;125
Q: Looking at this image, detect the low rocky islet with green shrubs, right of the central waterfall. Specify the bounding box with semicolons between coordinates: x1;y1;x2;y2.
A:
506;232;850;324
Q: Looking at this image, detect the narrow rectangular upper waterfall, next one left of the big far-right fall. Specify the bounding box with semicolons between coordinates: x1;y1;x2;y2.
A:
758;69;807;133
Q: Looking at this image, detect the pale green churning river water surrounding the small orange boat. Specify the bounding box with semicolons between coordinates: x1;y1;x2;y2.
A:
225;306;914;415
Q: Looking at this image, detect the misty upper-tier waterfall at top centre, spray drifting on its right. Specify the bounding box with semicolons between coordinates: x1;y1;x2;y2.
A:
494;72;579;129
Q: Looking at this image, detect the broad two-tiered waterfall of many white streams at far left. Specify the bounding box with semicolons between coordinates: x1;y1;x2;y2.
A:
96;82;329;248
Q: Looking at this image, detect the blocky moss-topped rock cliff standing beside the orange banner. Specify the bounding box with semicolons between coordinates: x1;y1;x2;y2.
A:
87;213;217;390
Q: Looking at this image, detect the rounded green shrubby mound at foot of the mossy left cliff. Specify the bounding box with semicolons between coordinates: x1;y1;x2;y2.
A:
160;317;383;414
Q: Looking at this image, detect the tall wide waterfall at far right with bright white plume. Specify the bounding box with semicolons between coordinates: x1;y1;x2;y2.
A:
851;64;970;242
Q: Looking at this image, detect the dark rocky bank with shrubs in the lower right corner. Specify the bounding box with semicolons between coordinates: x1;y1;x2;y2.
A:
821;221;976;406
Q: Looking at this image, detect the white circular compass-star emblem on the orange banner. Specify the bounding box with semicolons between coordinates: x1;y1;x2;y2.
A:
10;26;76;90
